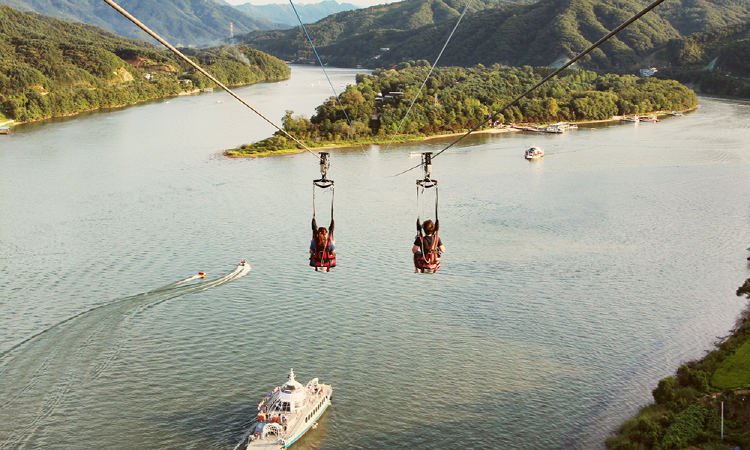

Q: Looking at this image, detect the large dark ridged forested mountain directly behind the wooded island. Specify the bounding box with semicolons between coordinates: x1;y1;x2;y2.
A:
318;0;680;70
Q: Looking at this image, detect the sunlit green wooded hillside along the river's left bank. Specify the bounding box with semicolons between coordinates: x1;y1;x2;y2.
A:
0;6;290;121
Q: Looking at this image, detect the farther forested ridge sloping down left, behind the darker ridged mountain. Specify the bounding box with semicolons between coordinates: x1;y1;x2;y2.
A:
240;0;514;59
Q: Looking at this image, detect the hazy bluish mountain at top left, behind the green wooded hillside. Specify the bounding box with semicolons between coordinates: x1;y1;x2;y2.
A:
0;0;288;47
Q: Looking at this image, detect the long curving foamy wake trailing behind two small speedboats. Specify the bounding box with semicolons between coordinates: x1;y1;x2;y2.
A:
0;264;250;449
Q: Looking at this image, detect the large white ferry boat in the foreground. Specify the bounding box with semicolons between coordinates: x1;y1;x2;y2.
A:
247;370;333;450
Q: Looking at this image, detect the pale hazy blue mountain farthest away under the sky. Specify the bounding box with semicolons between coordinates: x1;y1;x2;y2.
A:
232;0;359;27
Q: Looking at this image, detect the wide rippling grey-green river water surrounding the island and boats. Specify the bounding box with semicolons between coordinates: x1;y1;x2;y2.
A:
0;67;750;450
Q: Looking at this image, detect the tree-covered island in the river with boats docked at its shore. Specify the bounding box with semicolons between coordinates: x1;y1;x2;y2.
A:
226;60;698;156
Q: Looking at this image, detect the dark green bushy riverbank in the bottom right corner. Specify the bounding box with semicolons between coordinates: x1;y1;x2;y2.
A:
607;278;750;450
